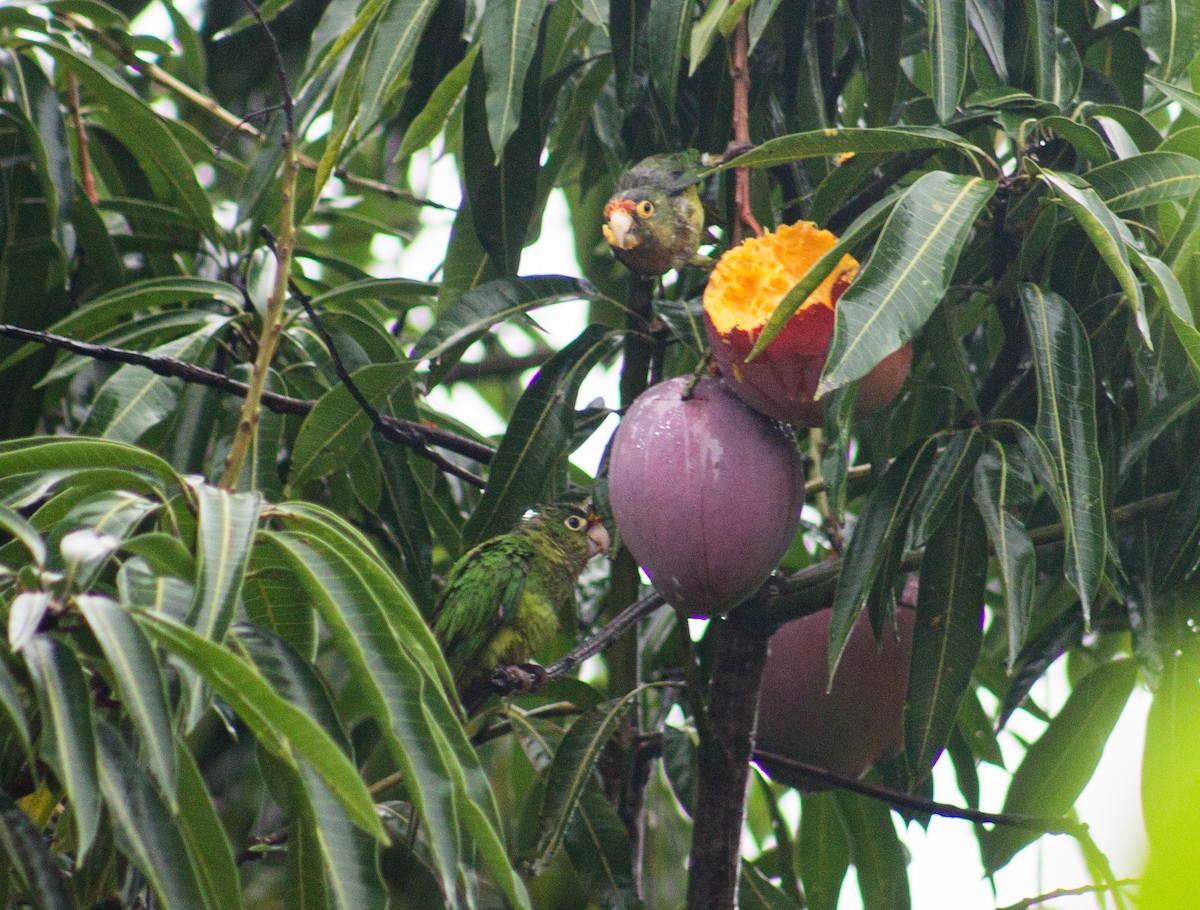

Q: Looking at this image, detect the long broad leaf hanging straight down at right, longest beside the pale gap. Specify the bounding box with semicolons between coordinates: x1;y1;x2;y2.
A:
1021;285;1106;623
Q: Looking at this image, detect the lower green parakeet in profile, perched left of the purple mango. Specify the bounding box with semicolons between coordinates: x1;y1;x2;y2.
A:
433;504;608;693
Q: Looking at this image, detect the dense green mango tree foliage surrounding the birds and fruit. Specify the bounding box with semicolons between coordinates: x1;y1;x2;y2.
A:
0;0;1200;910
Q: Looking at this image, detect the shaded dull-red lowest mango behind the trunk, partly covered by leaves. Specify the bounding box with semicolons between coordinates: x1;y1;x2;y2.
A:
756;606;914;789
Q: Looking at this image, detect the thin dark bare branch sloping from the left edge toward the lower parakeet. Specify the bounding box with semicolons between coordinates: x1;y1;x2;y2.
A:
0;323;496;473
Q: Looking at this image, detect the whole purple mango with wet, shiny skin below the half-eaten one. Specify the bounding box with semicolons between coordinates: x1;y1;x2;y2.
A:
608;376;804;616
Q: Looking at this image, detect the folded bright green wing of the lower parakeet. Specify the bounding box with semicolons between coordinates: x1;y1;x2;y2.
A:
433;537;534;678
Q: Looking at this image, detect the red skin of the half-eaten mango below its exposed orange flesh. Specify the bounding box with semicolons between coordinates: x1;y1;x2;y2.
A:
704;305;912;426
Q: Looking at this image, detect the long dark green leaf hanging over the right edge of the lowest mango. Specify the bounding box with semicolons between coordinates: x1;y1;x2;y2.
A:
904;491;988;791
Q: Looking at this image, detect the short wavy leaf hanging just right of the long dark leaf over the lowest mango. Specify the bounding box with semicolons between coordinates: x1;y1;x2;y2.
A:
974;442;1037;669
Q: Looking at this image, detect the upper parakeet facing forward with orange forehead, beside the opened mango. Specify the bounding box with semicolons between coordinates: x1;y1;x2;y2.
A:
602;151;704;276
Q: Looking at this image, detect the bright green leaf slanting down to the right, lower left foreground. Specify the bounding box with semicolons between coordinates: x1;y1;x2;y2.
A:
134;611;386;840
